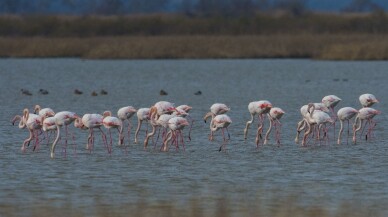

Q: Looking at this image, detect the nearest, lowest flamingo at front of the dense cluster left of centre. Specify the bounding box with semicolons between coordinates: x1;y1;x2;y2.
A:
163;117;189;151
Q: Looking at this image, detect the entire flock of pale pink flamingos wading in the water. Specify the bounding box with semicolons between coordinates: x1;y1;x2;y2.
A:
12;94;380;158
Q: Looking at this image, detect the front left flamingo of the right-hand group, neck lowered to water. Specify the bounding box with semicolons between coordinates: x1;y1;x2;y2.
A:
302;103;334;146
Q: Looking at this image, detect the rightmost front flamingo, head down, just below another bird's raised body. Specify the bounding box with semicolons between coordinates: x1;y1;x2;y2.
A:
353;107;381;143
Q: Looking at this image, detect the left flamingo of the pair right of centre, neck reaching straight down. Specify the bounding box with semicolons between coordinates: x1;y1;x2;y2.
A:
244;100;272;147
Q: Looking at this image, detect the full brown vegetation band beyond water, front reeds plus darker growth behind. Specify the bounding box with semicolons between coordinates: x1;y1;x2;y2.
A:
0;13;388;60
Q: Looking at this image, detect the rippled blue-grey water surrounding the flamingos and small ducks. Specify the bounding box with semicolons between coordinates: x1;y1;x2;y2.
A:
0;59;388;216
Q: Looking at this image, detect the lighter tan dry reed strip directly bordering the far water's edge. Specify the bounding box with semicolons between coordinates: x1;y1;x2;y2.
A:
0;34;388;60
